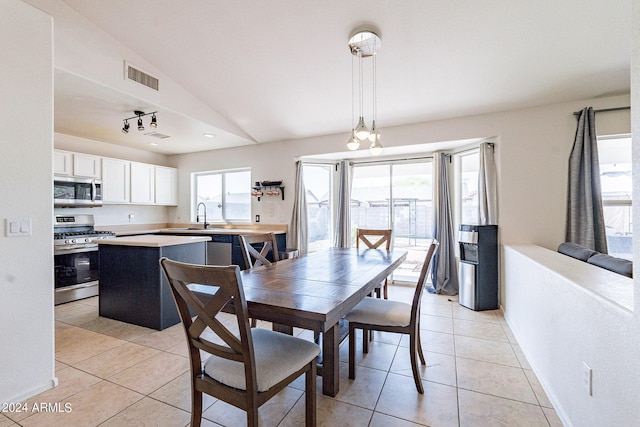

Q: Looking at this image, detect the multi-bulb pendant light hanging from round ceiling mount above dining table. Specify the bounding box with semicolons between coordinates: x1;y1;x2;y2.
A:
347;30;382;155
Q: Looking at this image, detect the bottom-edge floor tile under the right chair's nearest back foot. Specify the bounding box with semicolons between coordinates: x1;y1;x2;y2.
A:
375;374;458;427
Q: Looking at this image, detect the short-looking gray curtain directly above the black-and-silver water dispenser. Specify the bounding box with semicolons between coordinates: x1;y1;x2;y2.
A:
478;142;498;225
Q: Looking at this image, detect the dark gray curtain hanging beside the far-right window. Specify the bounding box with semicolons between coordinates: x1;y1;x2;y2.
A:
565;107;608;253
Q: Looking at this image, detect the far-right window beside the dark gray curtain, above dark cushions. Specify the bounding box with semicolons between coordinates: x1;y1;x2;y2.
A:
598;136;633;259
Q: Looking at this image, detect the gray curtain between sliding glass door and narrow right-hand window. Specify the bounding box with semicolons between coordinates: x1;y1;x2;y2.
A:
431;153;458;295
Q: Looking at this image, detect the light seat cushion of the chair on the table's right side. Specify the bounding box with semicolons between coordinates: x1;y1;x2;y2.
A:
345;297;411;326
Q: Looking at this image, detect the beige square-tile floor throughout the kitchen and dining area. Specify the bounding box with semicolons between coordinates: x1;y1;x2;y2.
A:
0;286;562;427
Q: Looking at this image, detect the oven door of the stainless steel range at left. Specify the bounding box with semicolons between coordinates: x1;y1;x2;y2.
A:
54;245;99;305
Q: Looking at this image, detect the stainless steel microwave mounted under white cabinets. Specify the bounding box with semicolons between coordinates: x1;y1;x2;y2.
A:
53;176;102;208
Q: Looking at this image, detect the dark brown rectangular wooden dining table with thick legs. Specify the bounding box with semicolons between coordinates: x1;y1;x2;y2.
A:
241;248;407;397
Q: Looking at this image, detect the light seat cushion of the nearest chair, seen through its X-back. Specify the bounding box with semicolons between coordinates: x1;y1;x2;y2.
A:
204;328;320;392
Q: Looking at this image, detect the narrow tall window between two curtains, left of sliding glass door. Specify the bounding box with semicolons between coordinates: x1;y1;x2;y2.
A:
302;163;334;252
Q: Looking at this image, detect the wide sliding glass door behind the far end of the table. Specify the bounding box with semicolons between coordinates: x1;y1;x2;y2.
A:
351;159;433;282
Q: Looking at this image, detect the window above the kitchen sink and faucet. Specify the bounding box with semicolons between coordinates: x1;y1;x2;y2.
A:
192;169;251;222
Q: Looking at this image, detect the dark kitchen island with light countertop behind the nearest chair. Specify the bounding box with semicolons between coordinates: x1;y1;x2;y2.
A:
99;234;210;330
